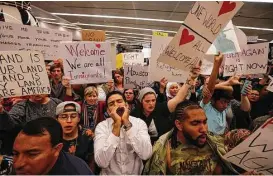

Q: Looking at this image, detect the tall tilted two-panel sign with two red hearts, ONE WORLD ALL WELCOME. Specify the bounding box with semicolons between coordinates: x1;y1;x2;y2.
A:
158;1;243;72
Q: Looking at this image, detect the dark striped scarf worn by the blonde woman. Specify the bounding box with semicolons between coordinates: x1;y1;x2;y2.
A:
82;101;98;130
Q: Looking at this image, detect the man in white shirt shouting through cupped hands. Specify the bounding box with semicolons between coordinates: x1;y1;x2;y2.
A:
94;91;152;175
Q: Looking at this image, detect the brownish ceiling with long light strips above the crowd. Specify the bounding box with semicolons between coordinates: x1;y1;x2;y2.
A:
31;1;273;43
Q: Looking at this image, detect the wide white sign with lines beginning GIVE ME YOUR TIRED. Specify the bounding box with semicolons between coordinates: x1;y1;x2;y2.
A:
0;22;72;60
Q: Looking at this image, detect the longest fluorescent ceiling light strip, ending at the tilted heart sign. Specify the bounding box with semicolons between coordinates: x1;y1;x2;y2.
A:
51;13;183;24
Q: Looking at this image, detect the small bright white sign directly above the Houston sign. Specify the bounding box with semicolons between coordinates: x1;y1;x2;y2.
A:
122;52;144;66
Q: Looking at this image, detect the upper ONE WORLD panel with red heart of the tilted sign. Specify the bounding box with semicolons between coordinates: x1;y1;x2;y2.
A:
184;1;244;43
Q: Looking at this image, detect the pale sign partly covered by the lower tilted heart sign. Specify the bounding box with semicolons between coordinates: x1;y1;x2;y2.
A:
149;36;188;82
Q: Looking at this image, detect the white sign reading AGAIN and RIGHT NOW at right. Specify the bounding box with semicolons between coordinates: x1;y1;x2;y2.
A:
224;43;268;76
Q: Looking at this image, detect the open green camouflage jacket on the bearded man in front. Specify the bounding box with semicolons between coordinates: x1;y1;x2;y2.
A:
143;130;238;175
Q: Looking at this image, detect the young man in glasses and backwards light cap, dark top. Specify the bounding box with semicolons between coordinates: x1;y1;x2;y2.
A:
56;101;95;172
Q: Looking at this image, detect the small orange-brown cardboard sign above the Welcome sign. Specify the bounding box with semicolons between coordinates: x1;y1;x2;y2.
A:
82;30;105;42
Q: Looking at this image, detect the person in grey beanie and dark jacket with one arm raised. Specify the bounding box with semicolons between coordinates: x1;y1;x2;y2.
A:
131;73;196;141
